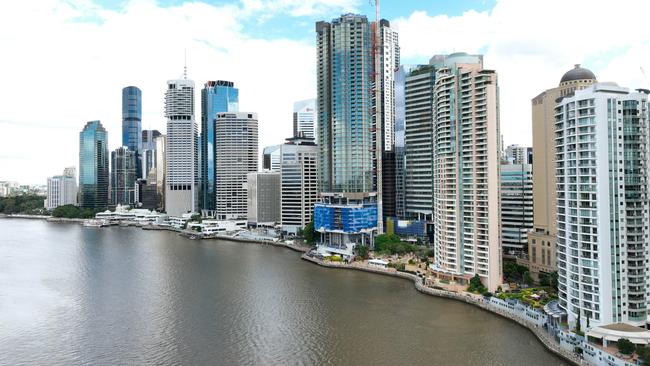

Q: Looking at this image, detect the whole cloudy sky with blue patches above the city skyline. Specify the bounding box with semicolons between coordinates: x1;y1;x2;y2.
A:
0;0;650;184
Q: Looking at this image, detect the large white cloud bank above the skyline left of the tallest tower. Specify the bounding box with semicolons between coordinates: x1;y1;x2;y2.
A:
0;0;324;183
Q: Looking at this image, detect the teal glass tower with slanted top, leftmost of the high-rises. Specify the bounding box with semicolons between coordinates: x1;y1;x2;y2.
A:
79;121;108;209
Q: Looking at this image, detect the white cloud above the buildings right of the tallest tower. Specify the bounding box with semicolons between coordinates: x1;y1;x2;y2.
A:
393;0;650;149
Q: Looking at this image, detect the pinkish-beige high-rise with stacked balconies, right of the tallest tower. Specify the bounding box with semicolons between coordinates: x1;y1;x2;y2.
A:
430;53;502;291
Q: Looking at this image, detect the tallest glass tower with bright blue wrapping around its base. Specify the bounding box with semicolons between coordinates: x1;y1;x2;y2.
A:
314;14;383;257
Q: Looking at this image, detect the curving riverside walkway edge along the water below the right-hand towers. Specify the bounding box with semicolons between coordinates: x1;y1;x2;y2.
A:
301;253;588;366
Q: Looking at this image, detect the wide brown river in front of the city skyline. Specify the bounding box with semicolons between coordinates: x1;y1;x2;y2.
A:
0;219;566;366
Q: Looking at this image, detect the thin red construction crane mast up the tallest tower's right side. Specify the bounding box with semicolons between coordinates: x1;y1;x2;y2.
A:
370;0;384;234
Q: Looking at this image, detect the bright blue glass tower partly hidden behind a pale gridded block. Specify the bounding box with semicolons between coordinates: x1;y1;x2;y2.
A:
200;80;239;212
